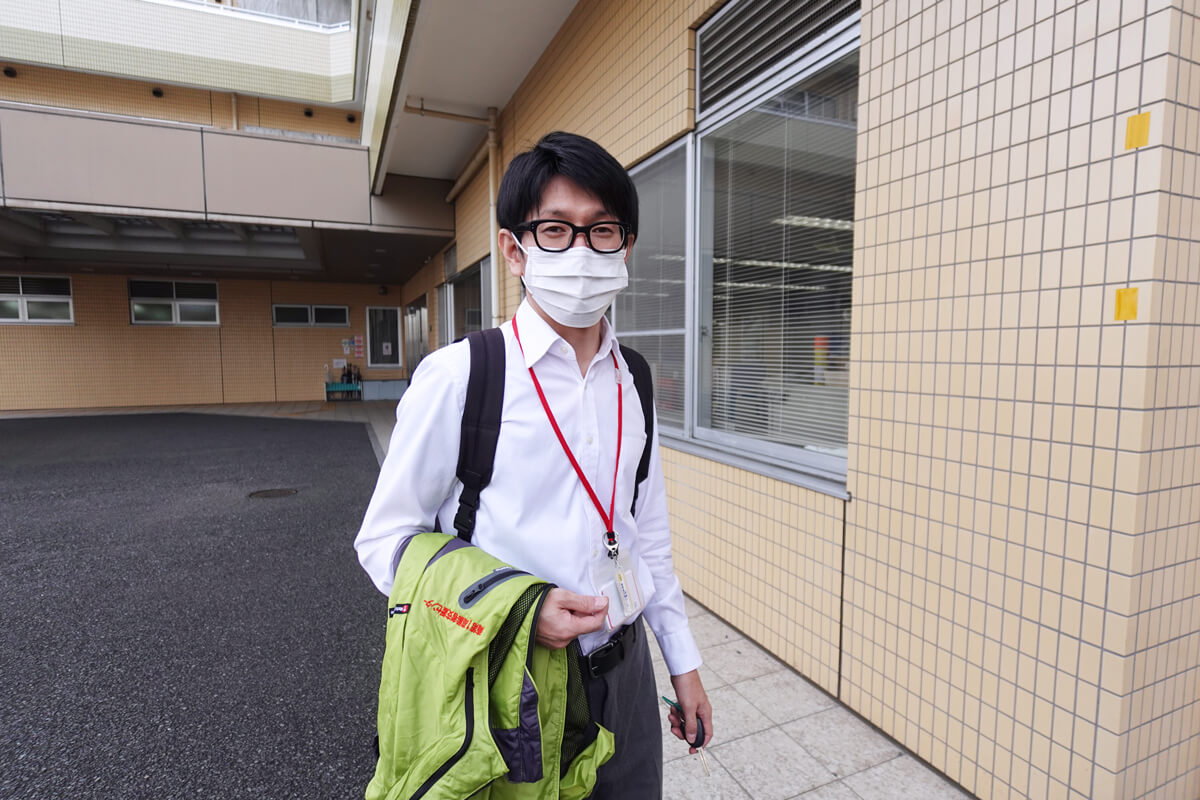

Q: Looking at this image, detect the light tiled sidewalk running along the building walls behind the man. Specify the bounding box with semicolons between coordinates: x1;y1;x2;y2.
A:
0;401;967;800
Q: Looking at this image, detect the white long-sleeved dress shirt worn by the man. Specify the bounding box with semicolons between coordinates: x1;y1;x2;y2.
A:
354;302;701;675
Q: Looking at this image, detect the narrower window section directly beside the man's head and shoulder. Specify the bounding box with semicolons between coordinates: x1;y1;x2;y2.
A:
613;146;688;428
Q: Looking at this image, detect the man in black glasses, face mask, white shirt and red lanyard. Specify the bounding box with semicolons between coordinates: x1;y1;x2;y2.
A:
355;133;713;800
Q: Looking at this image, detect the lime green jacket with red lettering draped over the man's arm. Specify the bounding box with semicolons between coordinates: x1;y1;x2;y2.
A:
366;533;614;800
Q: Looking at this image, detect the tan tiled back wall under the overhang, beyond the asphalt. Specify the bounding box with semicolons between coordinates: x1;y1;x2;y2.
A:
0;273;408;410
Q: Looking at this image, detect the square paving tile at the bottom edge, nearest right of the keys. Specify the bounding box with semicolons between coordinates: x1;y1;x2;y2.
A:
709;728;835;800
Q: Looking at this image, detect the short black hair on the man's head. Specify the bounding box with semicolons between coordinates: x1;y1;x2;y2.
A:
496;131;637;235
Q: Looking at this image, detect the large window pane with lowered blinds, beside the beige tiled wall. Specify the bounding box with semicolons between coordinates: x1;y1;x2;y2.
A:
697;52;858;469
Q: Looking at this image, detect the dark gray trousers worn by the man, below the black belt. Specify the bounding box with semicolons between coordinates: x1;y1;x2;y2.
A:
587;616;662;800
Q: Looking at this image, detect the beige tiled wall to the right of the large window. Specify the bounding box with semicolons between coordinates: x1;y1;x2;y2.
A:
842;0;1200;798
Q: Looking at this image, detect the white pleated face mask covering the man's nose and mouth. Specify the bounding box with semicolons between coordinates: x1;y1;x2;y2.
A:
514;237;629;327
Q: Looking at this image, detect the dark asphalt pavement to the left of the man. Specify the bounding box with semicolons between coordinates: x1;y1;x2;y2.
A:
0;414;386;800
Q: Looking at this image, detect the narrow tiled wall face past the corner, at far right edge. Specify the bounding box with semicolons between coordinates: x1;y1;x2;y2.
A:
1111;2;1200;798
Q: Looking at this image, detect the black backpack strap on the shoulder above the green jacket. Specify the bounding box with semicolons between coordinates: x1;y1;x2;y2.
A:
454;327;504;542
